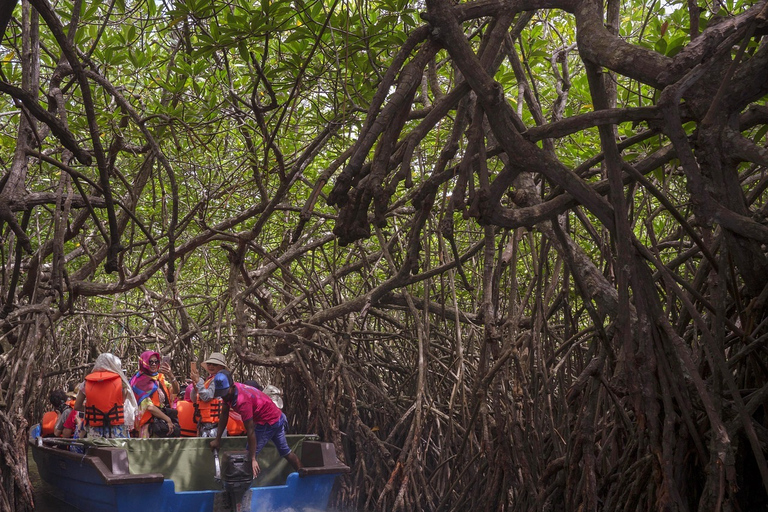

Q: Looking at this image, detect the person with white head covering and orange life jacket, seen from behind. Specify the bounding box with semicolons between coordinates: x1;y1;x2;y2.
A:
74;352;138;438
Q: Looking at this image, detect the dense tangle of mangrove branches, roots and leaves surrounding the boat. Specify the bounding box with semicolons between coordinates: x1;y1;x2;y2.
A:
0;0;768;511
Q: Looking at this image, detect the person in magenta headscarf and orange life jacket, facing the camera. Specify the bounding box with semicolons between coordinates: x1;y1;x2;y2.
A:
131;350;179;438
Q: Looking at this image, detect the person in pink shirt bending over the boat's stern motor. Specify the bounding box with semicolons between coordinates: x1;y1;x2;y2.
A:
210;370;302;477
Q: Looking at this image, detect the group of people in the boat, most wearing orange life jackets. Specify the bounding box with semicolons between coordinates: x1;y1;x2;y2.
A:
41;350;301;476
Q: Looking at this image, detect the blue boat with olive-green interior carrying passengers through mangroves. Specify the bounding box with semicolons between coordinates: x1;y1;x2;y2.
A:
29;433;349;512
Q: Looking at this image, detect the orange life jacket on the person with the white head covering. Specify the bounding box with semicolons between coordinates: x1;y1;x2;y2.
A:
85;371;125;427
